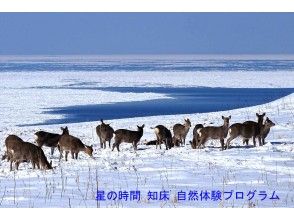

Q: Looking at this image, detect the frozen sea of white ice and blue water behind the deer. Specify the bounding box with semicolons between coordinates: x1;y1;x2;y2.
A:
0;55;294;126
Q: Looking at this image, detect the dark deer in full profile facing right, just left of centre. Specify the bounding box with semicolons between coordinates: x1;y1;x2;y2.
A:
112;124;145;151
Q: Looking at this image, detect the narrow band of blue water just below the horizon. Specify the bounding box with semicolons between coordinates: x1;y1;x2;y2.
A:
0;56;294;72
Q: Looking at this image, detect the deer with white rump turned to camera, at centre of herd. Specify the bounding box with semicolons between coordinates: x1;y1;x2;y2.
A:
154;125;174;150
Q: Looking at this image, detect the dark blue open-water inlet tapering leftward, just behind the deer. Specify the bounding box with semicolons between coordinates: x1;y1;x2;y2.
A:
25;87;294;124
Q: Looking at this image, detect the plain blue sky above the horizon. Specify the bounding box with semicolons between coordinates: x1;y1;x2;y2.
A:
0;13;294;55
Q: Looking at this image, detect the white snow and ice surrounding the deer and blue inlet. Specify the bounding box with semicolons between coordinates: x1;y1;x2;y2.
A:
0;71;294;207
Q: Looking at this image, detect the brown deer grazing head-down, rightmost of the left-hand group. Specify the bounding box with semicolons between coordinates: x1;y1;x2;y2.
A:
58;127;93;161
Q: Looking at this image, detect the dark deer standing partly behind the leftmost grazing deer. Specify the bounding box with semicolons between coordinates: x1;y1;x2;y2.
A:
35;131;60;156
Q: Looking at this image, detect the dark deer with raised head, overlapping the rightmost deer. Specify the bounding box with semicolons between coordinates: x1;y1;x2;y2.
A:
226;113;265;149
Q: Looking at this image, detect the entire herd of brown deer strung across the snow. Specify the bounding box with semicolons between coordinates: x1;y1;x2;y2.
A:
2;113;275;171
